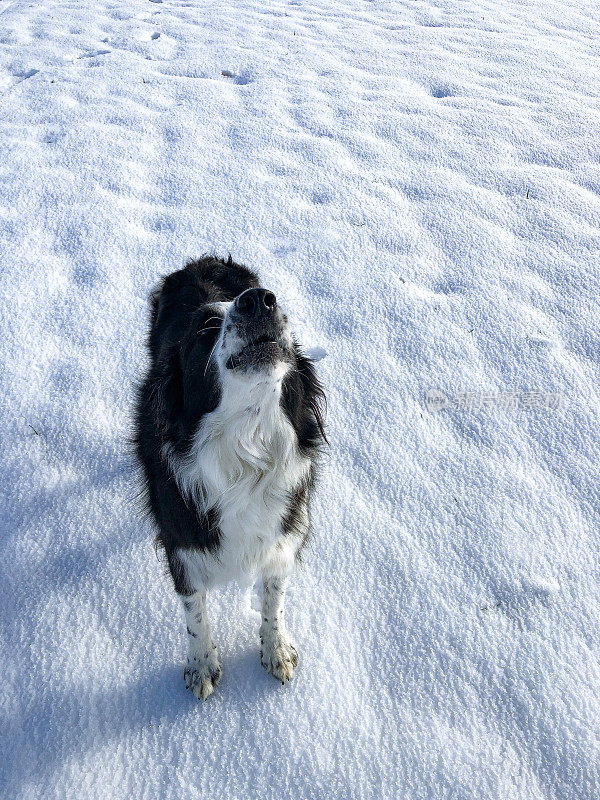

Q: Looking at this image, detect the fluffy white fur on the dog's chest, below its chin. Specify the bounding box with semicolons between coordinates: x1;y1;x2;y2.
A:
170;368;310;585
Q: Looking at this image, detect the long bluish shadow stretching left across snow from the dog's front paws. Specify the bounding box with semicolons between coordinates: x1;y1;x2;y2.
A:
3;648;290;792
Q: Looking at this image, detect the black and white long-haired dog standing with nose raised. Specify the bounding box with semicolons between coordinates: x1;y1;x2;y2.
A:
135;256;325;699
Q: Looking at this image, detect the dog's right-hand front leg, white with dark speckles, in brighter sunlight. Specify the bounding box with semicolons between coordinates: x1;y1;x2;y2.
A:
260;576;298;683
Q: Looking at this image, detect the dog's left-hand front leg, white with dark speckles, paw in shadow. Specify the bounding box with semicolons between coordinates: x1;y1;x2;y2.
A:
182;592;221;700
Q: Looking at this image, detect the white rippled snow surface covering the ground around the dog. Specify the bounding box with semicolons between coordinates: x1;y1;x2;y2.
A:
0;0;600;800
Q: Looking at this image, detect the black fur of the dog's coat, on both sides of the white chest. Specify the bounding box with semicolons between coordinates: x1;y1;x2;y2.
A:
134;256;325;595
